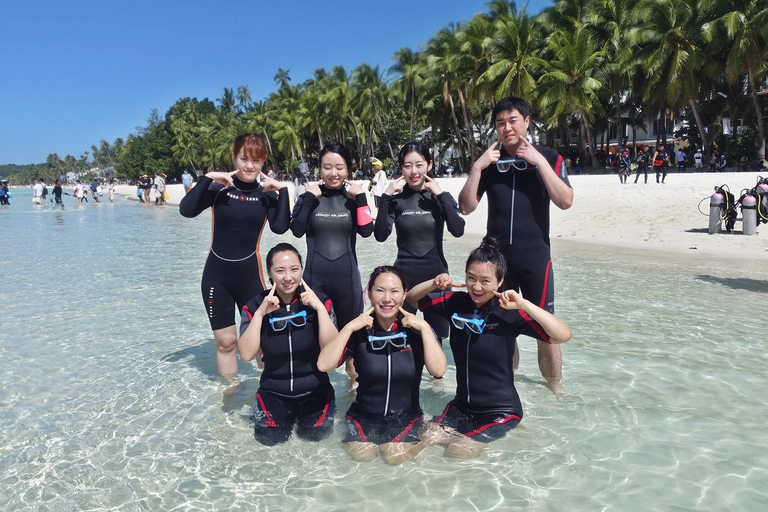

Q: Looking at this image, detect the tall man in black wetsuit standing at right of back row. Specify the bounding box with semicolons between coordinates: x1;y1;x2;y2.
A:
459;96;573;394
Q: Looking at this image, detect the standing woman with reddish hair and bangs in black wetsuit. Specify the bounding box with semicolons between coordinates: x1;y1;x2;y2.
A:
179;133;291;387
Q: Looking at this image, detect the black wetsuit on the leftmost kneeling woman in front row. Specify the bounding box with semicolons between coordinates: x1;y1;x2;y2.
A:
240;291;336;446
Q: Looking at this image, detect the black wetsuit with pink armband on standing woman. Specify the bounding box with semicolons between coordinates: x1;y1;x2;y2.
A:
291;186;373;328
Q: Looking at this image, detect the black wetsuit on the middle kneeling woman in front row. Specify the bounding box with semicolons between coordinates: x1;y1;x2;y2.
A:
339;319;424;444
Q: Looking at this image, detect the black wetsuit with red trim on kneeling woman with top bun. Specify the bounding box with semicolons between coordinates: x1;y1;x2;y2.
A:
419;291;549;442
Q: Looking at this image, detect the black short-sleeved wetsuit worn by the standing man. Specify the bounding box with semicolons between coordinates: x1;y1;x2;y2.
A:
477;146;571;313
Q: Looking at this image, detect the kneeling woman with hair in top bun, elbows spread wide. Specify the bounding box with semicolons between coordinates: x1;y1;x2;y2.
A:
407;237;571;458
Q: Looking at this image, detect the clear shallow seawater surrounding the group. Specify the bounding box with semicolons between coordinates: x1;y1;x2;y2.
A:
0;190;768;511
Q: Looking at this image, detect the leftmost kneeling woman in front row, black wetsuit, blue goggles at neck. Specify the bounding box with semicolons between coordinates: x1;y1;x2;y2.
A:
238;243;339;446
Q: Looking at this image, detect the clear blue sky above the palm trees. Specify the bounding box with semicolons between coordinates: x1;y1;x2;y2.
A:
0;0;550;164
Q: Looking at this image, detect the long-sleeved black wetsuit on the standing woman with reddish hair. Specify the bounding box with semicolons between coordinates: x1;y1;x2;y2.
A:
179;176;290;331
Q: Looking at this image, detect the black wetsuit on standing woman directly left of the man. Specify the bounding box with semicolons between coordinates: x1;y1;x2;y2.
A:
374;186;464;338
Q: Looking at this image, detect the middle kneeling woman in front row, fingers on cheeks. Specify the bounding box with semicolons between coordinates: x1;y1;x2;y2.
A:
317;266;446;464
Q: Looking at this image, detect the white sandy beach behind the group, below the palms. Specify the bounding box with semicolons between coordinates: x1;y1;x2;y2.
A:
116;172;768;260
